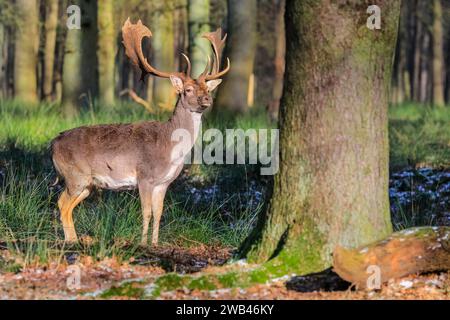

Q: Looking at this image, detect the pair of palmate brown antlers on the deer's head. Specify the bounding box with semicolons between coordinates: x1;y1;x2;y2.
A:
122;18;230;81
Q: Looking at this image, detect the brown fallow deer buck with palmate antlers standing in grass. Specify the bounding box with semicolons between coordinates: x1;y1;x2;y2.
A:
51;18;230;245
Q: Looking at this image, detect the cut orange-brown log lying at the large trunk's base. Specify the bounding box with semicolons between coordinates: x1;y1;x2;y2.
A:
333;227;450;288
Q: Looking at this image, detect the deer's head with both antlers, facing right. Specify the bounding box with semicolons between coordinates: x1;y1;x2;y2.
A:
122;18;230;113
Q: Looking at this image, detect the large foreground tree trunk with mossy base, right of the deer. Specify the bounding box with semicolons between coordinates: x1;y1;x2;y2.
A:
241;0;400;273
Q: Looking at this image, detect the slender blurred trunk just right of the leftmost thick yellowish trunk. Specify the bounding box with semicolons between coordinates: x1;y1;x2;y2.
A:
42;0;58;101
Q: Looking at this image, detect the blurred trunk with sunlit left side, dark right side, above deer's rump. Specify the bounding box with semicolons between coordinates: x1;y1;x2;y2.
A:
61;0;97;117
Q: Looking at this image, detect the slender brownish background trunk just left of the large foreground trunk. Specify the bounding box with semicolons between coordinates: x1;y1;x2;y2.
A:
269;0;286;120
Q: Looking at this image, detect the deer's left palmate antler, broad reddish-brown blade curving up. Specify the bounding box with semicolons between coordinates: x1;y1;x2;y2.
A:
122;18;185;80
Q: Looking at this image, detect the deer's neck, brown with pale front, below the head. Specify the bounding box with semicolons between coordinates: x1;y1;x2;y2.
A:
169;99;202;149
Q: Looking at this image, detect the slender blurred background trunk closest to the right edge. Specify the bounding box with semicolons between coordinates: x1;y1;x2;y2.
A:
433;0;445;107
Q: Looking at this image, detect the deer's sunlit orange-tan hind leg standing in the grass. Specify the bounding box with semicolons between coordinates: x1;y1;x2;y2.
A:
58;189;89;242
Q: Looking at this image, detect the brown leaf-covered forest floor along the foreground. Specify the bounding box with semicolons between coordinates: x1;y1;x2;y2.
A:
0;246;450;300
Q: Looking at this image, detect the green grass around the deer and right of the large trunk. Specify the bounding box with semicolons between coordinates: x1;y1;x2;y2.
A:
0;100;450;264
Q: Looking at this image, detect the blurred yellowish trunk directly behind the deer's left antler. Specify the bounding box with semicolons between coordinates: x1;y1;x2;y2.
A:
152;0;176;109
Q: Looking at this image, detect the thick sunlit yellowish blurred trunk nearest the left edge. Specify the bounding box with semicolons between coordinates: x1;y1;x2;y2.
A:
14;0;39;103
